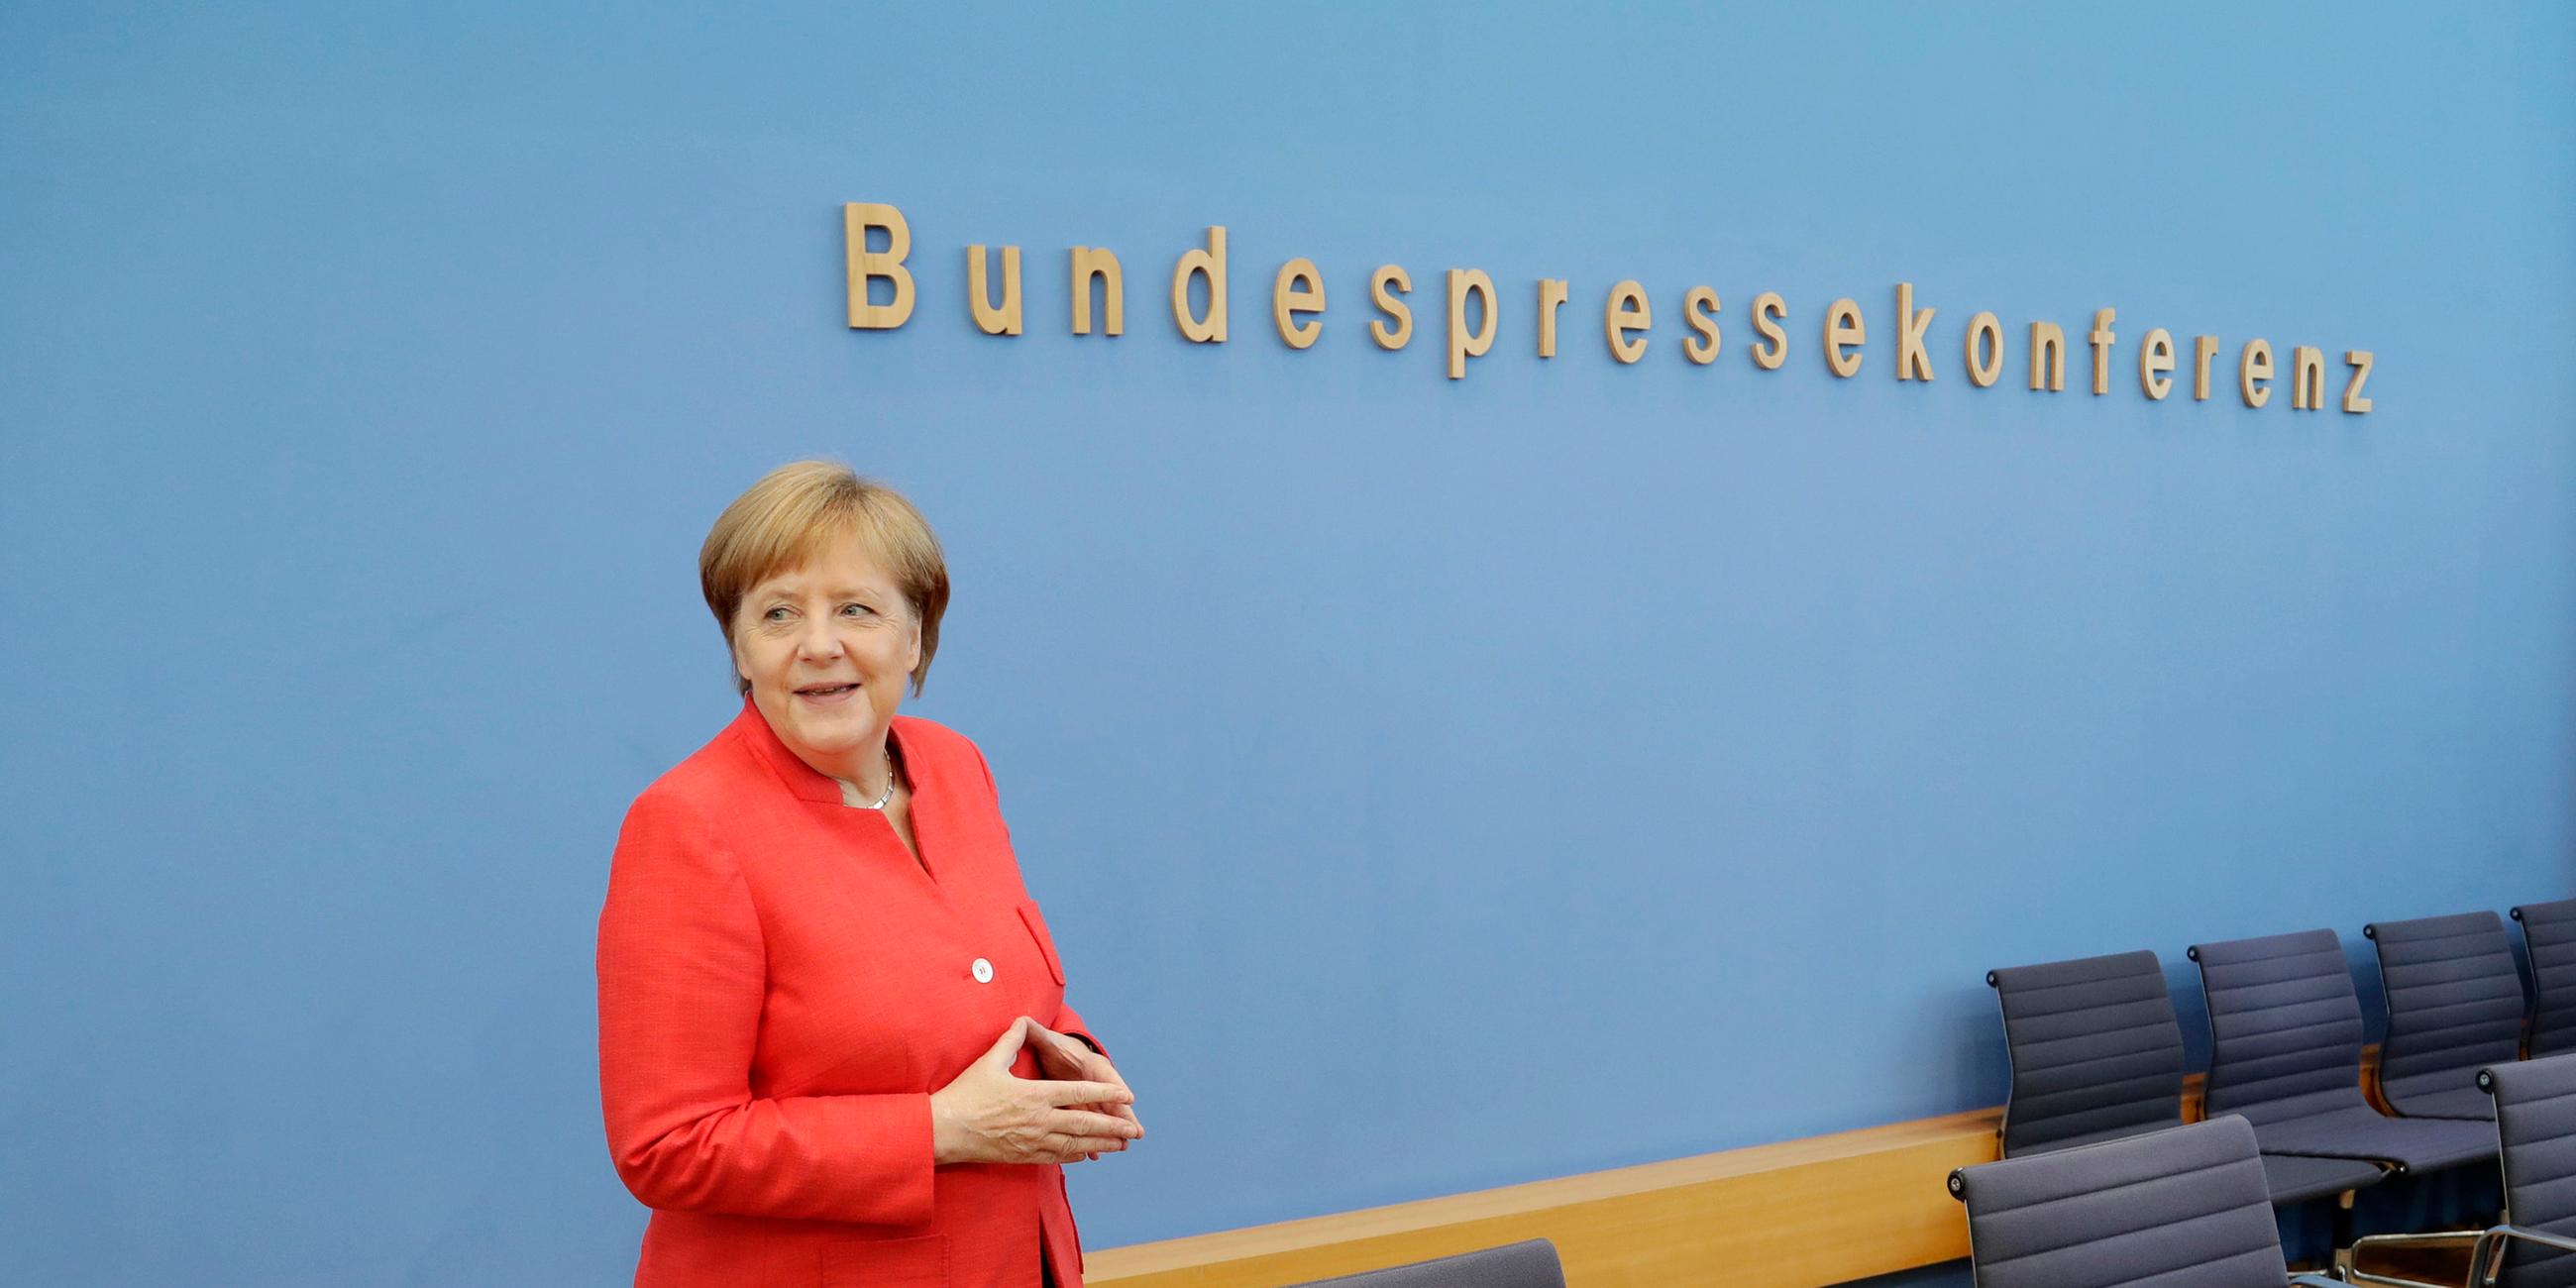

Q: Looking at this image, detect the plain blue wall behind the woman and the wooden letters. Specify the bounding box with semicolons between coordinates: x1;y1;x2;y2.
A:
0;5;2576;1285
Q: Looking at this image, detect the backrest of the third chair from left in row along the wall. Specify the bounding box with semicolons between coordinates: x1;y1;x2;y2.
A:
2362;912;2522;1113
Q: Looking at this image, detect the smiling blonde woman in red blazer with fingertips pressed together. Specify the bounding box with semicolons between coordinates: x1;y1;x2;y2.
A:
597;461;1143;1288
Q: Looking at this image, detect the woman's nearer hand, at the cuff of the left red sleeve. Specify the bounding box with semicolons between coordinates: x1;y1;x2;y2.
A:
930;1015;1143;1164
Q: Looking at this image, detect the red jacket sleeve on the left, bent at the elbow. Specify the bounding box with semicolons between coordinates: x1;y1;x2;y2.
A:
597;791;935;1227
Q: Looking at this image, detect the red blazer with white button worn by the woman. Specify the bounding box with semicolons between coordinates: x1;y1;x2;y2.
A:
597;700;1087;1288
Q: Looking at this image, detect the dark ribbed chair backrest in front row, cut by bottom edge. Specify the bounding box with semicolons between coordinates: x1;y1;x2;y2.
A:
1950;1116;2288;1288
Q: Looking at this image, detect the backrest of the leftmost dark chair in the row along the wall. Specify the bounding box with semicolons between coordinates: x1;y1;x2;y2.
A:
1986;953;2182;1159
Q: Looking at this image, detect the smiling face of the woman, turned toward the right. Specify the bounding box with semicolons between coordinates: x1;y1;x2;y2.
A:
734;531;922;781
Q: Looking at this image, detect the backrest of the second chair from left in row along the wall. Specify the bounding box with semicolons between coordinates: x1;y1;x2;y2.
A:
2193;930;2370;1124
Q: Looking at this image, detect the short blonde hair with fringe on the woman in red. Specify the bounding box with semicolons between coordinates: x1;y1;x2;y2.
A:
698;461;948;696
